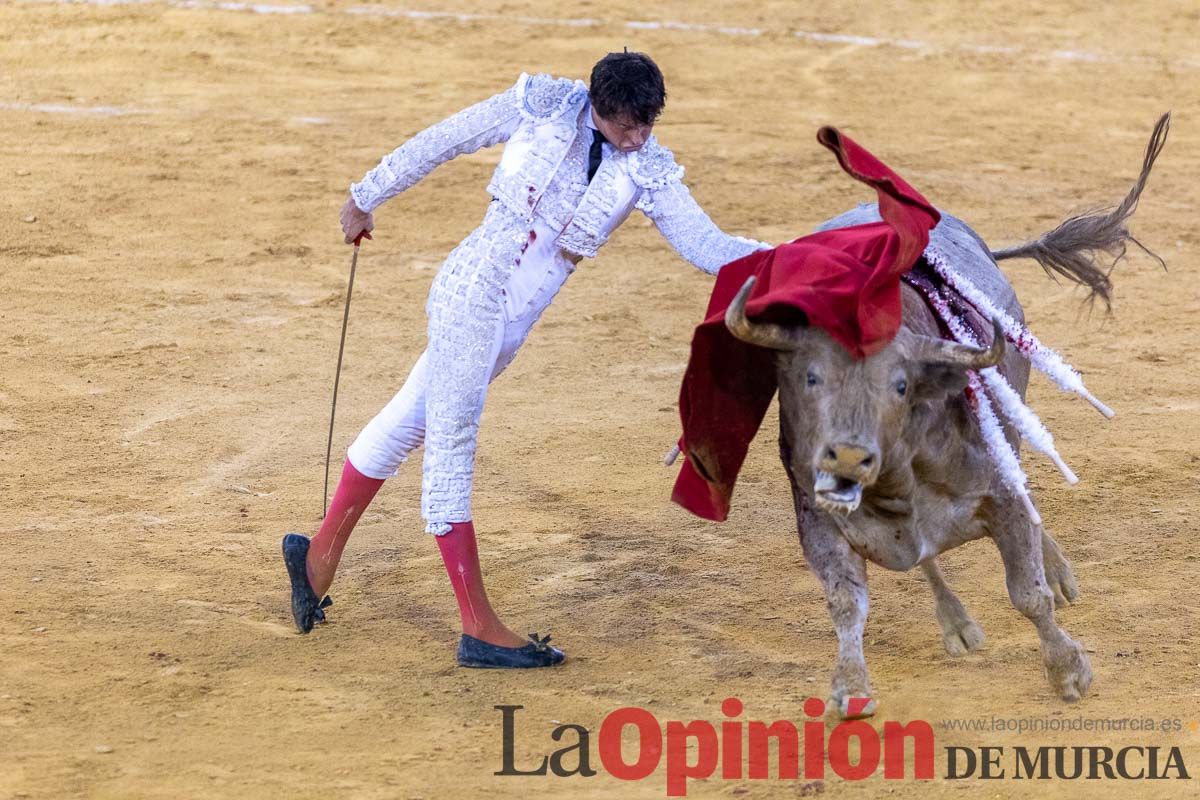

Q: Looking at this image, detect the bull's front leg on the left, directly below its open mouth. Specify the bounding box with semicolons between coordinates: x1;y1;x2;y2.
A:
796;497;875;718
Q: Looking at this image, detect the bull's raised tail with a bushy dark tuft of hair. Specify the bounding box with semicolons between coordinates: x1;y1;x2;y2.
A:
992;112;1171;309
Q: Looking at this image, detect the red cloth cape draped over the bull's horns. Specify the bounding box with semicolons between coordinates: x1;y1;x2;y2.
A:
671;127;941;522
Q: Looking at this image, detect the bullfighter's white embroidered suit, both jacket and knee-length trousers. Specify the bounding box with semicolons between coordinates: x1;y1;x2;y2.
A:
348;74;768;534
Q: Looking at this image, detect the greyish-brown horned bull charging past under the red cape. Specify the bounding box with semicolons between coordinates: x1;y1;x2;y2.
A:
725;116;1168;717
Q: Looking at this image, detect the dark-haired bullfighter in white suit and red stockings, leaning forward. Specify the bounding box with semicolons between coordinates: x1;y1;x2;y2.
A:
283;52;768;668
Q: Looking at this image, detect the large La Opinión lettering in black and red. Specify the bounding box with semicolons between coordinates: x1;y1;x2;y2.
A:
493;697;934;798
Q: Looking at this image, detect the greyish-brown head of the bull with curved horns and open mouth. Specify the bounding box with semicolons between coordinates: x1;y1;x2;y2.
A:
725;277;1004;515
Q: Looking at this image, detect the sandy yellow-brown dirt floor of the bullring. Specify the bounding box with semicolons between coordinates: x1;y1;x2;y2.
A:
0;0;1200;800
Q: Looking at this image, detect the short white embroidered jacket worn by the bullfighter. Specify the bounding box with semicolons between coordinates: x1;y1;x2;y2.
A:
350;73;768;273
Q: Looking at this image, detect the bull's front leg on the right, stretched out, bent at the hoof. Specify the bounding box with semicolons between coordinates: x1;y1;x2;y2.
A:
989;492;1092;703
